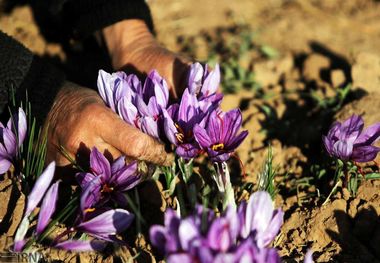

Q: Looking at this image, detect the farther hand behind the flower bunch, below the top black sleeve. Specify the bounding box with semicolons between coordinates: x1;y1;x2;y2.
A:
103;19;190;98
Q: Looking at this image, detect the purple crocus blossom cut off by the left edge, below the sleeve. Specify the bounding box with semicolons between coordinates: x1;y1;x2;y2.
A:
0;108;27;174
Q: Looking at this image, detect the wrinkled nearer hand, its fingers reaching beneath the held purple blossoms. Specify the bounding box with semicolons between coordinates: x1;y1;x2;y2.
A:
45;83;172;166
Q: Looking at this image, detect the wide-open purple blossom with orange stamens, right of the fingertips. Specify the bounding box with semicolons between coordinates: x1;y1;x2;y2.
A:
194;109;248;162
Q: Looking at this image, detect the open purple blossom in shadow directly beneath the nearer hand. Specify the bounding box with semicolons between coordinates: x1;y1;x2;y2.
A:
76;147;141;207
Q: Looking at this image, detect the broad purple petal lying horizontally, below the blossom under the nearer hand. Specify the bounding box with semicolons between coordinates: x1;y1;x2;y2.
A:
77;209;134;235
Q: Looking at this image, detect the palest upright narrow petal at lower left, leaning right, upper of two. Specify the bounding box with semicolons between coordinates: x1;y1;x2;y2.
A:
25;162;55;216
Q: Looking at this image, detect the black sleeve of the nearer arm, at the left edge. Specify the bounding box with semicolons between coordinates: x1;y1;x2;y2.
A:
0;31;65;124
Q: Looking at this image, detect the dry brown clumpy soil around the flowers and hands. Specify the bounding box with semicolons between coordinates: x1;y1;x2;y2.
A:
0;0;380;262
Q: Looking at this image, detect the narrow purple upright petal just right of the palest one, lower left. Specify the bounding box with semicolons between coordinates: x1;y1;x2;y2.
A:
36;181;60;236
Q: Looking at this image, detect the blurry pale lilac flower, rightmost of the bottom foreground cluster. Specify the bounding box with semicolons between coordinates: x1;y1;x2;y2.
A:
238;191;284;248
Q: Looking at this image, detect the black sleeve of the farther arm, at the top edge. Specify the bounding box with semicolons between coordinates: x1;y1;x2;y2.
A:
31;0;153;40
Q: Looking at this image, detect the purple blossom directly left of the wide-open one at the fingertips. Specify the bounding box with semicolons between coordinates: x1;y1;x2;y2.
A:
163;89;207;159
